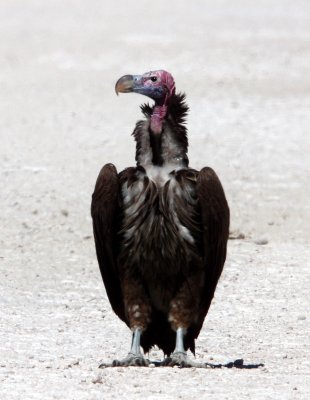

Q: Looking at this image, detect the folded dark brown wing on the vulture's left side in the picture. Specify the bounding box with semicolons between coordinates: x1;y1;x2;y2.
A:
91;164;127;323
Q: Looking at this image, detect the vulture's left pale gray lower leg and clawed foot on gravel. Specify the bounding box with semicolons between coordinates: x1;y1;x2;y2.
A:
99;328;149;368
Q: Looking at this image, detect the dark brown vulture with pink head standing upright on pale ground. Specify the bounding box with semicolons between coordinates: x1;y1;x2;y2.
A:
91;70;229;367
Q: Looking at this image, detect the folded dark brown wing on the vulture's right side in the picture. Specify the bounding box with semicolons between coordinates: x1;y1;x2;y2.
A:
197;167;229;328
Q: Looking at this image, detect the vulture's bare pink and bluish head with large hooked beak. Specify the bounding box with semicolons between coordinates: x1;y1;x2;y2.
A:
115;70;175;104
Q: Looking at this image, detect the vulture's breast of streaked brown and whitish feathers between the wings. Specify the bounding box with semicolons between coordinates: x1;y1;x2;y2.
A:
120;167;201;281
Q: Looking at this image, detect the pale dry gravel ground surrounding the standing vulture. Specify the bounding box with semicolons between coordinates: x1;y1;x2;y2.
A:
0;0;310;400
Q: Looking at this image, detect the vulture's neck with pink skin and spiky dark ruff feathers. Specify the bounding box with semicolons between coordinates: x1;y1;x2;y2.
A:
133;94;188;171
